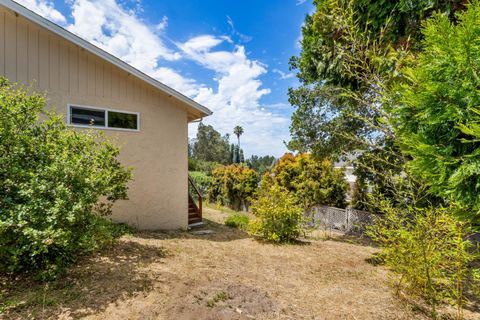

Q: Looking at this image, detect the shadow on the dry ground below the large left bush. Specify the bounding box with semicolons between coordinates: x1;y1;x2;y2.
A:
0;238;167;319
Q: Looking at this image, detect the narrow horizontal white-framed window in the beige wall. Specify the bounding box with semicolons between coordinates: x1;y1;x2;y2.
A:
68;105;140;131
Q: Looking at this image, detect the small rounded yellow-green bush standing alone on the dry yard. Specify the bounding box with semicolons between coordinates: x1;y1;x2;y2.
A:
248;185;303;242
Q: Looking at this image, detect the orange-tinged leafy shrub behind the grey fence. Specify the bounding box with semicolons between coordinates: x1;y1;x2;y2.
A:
262;153;349;208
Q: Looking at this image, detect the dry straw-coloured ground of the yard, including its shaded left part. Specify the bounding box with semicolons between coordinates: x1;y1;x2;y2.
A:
0;209;480;320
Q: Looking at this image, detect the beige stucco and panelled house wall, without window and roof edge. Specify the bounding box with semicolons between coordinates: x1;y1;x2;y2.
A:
0;6;188;229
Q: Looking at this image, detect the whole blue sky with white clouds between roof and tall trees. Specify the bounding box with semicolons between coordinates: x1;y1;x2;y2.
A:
17;0;313;156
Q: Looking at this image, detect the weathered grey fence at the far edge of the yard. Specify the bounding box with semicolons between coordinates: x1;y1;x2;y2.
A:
305;206;378;233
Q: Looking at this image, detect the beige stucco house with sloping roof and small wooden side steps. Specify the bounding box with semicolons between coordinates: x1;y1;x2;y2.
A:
0;0;212;229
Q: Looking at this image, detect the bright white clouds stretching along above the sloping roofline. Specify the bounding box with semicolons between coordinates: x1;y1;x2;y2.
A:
24;0;290;156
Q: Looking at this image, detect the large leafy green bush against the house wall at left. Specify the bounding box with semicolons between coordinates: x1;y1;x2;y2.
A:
0;78;131;276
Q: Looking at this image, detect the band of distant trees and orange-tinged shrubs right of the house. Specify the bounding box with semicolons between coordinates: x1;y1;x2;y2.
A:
189;123;348;210
